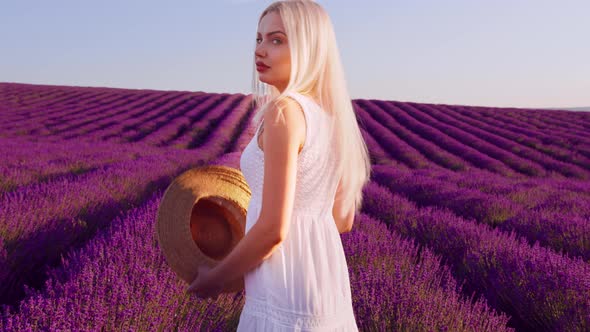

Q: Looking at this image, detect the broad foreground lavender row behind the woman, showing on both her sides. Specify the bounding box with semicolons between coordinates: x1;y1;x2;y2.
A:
0;191;511;331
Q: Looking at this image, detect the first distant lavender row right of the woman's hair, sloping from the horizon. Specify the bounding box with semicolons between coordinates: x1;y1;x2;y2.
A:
353;102;440;168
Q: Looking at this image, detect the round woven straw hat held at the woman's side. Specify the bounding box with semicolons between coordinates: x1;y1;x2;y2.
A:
156;165;251;293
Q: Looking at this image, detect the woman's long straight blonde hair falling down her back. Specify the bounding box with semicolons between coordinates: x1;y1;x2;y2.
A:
252;0;371;215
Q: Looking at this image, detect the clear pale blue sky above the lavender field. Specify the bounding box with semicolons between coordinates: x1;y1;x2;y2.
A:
0;0;590;108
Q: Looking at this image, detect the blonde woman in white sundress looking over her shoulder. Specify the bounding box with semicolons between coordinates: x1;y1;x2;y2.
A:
188;0;370;331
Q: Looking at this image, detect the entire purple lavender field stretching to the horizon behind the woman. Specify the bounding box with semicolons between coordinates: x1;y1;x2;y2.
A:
0;83;590;331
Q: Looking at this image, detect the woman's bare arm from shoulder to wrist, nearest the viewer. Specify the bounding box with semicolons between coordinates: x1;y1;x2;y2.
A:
211;98;305;284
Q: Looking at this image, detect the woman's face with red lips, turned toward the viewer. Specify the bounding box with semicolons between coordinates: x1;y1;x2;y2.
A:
255;12;291;92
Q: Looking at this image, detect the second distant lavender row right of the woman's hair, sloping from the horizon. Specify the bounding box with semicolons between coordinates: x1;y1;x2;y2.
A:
356;100;469;170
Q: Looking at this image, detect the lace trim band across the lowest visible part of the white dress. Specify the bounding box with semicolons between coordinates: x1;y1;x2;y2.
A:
242;296;354;328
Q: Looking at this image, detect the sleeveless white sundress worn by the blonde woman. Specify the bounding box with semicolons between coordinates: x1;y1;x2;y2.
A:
237;92;358;332
